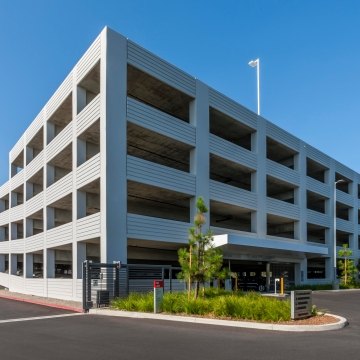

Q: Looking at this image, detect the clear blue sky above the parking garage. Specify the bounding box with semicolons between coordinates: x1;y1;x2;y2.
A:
0;0;360;184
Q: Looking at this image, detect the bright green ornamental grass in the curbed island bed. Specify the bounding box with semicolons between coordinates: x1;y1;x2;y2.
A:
112;289;290;322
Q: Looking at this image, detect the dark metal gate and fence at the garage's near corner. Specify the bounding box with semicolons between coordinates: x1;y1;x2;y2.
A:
83;261;186;311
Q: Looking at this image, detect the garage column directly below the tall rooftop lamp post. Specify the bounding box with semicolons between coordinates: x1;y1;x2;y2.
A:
251;117;267;238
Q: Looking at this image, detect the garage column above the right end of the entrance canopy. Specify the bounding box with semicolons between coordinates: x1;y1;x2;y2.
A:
294;142;307;243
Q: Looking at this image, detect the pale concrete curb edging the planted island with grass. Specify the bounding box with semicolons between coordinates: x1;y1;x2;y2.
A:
89;309;348;332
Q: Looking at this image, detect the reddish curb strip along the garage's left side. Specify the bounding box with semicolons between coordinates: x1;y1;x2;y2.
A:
0;289;84;312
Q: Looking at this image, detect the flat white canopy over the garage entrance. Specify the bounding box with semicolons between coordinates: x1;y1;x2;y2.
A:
214;234;328;261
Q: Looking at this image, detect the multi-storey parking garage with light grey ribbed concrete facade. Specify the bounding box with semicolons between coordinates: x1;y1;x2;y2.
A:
0;28;360;300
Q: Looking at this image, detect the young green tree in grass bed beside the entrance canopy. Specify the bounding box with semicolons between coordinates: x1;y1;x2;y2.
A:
178;197;223;299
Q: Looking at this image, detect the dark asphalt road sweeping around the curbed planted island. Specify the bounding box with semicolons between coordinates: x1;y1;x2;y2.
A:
0;291;360;360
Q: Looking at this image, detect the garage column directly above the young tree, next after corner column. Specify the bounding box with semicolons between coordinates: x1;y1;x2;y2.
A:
190;80;210;229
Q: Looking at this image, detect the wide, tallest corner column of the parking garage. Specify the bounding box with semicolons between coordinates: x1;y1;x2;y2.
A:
100;28;127;263
